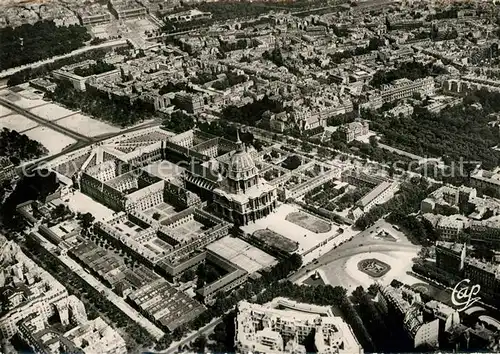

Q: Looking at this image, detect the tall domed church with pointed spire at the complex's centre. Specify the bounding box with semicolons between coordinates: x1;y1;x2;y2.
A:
213;133;277;225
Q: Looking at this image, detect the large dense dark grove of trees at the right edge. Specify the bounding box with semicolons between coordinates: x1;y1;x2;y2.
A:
363;90;500;169
